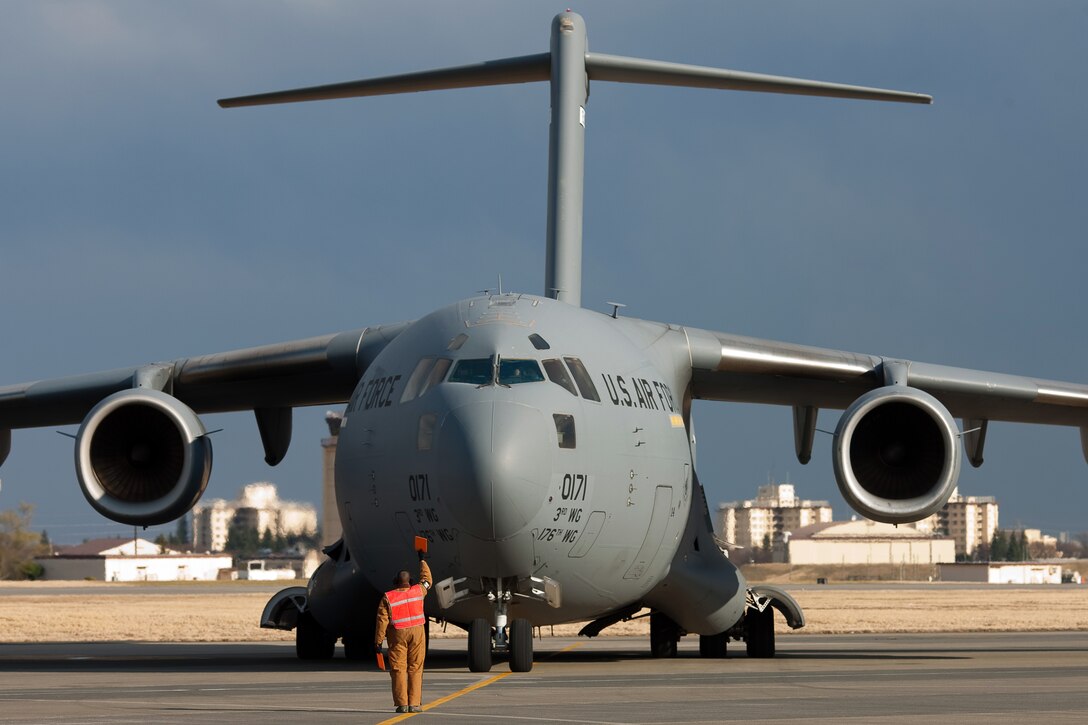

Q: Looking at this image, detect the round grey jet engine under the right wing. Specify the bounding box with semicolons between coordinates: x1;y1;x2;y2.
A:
832;385;960;524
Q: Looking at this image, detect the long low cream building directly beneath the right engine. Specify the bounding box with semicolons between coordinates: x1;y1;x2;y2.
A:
787;518;955;565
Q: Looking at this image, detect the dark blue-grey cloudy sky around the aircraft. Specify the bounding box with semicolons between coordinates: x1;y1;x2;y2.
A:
0;0;1088;541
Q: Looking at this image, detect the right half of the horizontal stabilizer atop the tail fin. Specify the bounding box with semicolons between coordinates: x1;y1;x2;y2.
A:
585;53;934;103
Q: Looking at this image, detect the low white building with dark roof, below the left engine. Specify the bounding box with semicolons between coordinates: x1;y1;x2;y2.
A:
35;539;233;581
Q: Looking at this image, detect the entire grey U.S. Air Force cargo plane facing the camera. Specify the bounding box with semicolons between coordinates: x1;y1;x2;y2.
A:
0;12;1088;672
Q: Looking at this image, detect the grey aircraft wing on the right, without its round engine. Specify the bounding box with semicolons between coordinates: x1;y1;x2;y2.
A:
685;329;1088;466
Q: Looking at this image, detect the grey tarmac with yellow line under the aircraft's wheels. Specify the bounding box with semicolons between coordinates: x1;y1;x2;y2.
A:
0;631;1088;725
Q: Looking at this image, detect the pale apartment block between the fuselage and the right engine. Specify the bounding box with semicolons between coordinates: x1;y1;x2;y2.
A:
718;483;831;549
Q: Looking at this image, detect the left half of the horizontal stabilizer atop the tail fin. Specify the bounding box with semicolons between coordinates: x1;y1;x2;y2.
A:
219;53;552;108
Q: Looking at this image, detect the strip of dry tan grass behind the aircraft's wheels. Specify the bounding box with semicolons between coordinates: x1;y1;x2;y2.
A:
0;582;1088;642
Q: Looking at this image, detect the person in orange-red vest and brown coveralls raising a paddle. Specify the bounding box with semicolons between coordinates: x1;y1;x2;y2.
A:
374;551;431;712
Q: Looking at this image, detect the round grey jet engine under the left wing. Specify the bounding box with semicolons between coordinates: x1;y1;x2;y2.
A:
75;389;211;526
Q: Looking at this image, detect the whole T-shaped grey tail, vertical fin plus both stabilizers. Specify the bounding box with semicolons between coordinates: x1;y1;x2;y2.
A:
219;11;932;306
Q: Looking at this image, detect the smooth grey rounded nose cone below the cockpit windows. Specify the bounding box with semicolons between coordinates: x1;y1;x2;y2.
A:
435;401;549;541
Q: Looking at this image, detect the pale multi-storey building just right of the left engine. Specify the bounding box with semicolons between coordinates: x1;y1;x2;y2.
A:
193;482;318;551
